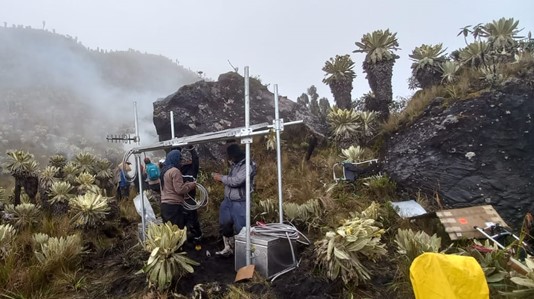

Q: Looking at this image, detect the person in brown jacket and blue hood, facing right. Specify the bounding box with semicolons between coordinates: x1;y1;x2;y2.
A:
160;150;196;229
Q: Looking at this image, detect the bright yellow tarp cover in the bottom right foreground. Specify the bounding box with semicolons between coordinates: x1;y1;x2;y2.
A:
410;252;489;299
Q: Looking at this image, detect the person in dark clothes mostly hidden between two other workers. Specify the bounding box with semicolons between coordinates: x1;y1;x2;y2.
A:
180;147;202;250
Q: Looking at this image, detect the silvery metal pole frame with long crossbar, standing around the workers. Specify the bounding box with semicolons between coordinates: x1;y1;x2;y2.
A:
123;66;303;265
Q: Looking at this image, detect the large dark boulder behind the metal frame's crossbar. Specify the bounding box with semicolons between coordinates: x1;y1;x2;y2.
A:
153;72;327;159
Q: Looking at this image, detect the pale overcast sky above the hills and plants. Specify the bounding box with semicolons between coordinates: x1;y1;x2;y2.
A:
0;0;534;100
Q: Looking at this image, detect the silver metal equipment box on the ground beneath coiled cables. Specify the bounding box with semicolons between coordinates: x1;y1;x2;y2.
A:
234;228;298;278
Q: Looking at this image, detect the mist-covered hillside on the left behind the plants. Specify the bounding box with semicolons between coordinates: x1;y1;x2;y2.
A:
0;28;199;165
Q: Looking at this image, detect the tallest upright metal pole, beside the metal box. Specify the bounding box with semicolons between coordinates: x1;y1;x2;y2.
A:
245;66;252;266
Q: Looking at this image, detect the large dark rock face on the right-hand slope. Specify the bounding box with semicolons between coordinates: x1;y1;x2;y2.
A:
383;81;534;228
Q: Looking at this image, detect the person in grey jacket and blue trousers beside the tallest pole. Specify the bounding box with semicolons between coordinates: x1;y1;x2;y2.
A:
212;143;256;256
